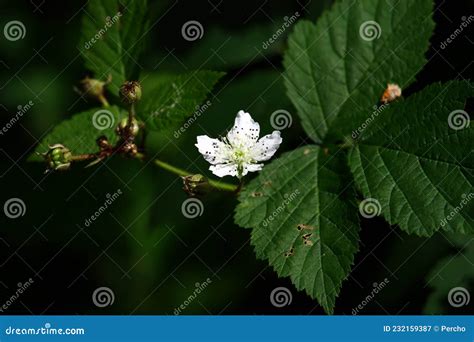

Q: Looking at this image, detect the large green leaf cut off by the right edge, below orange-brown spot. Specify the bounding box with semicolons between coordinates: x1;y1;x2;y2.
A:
349;81;474;236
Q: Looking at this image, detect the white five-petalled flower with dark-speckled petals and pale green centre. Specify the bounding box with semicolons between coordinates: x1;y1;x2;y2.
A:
196;110;282;178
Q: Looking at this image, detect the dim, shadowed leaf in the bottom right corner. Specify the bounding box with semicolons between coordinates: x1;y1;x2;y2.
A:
423;235;474;315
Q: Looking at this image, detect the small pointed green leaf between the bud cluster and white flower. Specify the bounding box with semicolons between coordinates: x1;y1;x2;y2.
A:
138;70;224;130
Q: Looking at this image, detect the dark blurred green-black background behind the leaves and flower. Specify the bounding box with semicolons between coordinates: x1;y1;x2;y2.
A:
0;0;474;314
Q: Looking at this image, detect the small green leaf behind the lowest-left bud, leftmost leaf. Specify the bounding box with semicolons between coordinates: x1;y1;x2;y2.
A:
30;106;127;160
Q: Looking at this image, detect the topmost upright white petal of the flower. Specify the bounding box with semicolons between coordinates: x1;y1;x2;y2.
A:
227;110;260;147
